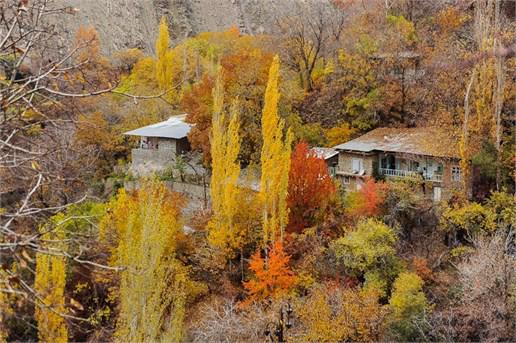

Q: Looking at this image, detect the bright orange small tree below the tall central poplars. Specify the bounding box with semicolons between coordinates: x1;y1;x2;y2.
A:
244;240;297;304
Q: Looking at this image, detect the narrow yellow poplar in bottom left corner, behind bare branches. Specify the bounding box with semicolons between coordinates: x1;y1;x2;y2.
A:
34;218;68;343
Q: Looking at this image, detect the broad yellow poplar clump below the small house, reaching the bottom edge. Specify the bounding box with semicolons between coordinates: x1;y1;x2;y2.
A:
105;180;195;342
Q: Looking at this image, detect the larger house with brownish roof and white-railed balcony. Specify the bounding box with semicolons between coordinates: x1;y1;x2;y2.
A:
334;127;471;201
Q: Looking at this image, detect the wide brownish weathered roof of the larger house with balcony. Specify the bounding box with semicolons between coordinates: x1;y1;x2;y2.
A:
334;127;459;158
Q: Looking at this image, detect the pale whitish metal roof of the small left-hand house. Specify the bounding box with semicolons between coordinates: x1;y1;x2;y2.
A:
124;114;192;139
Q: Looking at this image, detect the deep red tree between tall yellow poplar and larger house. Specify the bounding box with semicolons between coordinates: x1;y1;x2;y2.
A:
287;142;335;232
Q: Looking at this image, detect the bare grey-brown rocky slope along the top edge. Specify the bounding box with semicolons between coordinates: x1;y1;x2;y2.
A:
55;0;296;54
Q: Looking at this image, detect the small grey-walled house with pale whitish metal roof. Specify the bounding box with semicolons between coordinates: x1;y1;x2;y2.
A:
124;114;199;175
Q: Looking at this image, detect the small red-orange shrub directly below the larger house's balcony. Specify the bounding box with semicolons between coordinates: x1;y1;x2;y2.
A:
346;178;387;217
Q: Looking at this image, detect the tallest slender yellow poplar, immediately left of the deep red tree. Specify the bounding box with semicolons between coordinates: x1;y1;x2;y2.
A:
260;55;292;245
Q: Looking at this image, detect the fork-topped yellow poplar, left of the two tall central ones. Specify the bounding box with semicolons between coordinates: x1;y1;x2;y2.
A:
208;69;240;253
